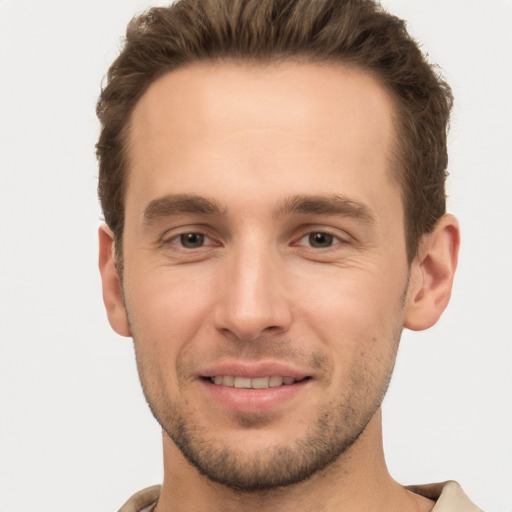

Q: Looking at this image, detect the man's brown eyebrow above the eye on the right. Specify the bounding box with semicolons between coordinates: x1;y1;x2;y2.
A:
273;194;375;224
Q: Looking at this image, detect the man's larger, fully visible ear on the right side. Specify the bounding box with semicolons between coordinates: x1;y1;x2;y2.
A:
404;214;460;331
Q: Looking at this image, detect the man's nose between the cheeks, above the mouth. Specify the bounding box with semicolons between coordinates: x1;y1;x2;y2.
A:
215;243;292;341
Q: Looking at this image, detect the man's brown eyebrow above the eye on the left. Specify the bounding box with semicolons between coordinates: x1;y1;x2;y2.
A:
142;194;226;223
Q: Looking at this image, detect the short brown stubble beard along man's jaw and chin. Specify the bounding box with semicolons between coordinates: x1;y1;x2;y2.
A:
132;331;400;493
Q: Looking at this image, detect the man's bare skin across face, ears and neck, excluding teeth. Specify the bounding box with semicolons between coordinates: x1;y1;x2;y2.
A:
100;62;459;511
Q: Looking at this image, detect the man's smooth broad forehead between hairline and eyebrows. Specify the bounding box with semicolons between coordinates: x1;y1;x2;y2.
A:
126;62;395;217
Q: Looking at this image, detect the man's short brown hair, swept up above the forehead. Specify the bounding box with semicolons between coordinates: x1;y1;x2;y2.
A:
97;0;452;261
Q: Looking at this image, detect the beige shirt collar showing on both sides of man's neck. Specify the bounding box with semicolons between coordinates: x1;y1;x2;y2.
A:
119;481;483;512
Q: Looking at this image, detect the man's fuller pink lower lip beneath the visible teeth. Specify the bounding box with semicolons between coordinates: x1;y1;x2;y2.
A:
201;379;311;414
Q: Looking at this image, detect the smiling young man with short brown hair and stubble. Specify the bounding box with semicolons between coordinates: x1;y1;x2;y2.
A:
98;0;479;512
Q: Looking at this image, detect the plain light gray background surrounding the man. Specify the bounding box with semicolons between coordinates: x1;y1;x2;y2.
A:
0;0;512;512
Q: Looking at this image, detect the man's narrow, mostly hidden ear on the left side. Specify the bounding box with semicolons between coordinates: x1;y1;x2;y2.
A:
98;224;131;336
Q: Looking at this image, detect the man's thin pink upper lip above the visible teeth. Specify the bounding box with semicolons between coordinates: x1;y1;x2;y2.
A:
199;361;311;380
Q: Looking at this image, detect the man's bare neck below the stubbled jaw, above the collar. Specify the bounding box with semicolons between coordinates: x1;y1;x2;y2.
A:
156;410;433;512
